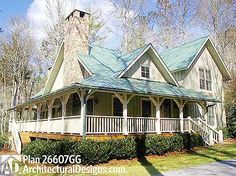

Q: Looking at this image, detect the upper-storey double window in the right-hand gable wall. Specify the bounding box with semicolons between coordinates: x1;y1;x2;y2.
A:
199;68;212;90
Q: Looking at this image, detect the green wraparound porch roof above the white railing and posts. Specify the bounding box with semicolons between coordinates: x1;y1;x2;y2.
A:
27;75;220;106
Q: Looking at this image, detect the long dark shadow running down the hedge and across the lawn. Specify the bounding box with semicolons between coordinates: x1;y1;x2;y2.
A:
135;135;162;176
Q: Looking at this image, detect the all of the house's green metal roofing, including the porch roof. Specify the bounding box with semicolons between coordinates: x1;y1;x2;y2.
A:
29;37;218;101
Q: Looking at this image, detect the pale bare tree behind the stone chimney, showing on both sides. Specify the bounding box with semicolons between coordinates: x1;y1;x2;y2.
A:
42;0;106;64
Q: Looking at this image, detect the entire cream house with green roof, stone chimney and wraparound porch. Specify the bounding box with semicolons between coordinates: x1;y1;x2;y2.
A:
10;10;231;153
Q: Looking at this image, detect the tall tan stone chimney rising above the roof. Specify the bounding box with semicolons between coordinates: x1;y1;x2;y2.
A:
63;10;90;86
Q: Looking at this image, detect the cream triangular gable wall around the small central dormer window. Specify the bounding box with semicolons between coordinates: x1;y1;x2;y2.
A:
123;53;166;82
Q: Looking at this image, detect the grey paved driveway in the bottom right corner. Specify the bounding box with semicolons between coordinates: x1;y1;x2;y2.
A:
159;159;236;176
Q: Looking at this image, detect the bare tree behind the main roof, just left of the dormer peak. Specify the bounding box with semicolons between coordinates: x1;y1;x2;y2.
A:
110;0;151;52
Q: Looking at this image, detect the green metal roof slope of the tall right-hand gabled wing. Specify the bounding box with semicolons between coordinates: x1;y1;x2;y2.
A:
160;37;208;72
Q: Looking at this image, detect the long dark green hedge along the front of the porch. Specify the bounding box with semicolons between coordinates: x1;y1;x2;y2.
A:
22;134;203;164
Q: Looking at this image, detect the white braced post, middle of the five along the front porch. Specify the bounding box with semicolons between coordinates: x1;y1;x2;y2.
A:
149;96;165;134
